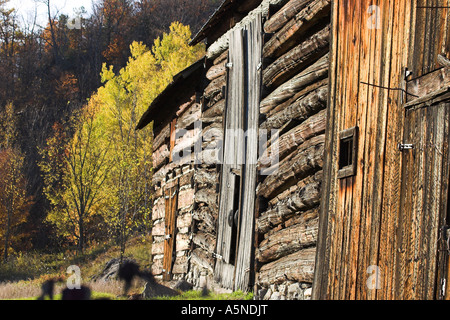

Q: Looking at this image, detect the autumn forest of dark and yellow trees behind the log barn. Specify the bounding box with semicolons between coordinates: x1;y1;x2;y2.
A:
0;0;219;264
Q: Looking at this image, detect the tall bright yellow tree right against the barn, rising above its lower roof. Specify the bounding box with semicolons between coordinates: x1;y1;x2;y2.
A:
91;22;204;255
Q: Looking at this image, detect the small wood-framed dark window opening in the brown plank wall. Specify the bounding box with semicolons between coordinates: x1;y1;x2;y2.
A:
338;127;358;179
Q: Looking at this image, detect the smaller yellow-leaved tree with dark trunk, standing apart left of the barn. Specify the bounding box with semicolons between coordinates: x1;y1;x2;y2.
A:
39;108;109;252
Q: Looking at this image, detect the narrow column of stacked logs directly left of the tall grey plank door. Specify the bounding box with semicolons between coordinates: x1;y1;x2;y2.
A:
186;50;228;289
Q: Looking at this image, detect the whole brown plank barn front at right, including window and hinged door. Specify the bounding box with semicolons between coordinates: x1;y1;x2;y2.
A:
313;0;450;300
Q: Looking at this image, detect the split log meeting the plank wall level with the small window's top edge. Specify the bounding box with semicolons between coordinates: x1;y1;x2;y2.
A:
259;110;327;168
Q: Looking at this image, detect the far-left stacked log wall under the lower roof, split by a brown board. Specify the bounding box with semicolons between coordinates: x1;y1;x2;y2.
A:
152;95;201;280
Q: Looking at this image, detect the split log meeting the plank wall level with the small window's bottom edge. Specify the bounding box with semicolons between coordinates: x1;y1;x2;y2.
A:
256;172;322;234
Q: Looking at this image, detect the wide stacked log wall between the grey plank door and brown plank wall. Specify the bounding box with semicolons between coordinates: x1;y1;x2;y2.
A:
255;0;331;300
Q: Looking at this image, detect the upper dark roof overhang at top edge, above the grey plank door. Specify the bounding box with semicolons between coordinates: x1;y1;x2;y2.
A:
189;0;262;45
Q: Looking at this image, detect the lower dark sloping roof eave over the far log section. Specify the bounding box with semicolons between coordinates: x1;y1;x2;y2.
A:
136;58;204;130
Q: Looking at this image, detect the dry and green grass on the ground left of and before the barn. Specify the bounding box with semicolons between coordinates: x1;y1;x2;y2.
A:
0;237;253;300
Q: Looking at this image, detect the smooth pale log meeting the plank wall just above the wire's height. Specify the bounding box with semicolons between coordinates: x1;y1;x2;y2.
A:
260;54;329;113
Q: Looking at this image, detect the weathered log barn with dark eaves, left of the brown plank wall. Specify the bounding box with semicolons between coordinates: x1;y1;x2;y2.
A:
138;0;331;299
